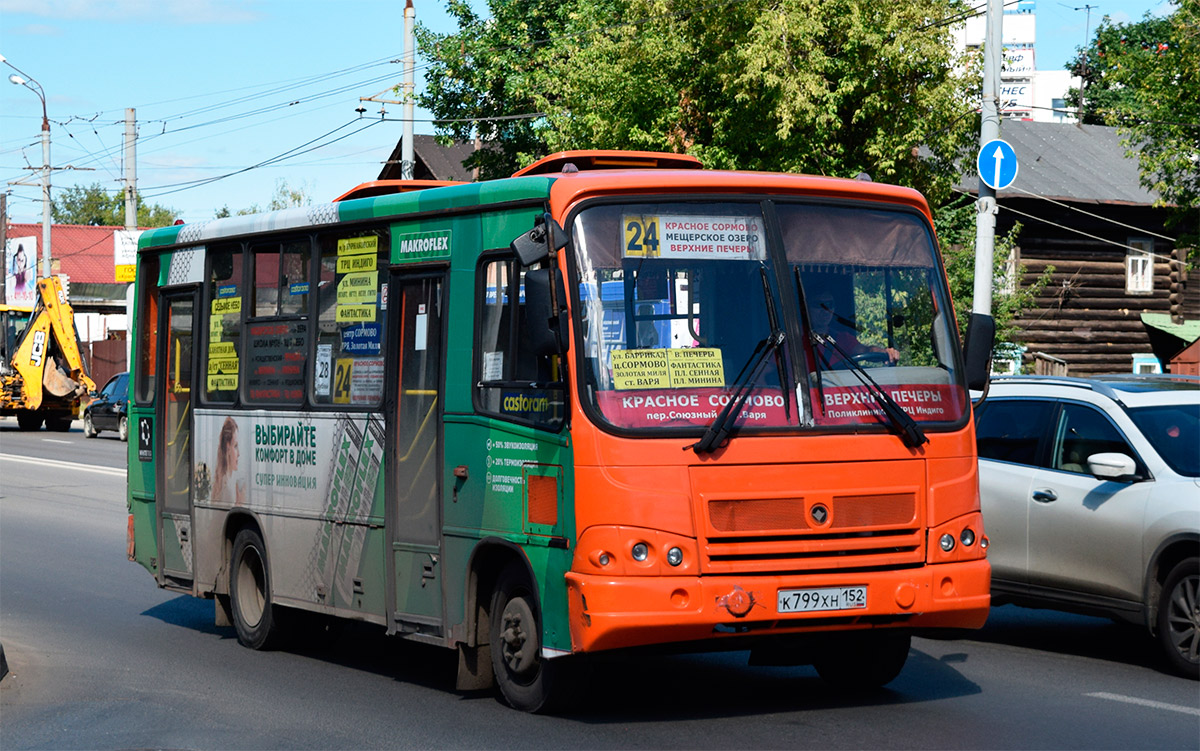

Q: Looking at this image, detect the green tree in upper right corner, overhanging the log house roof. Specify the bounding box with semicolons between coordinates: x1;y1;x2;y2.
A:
1073;0;1200;245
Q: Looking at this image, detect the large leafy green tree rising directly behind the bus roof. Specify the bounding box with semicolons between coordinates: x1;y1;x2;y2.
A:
419;0;976;202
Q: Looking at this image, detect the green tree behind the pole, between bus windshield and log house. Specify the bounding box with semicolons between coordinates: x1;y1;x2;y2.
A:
934;198;1054;362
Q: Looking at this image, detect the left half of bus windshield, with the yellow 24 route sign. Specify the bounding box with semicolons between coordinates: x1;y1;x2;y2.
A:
572;203;803;432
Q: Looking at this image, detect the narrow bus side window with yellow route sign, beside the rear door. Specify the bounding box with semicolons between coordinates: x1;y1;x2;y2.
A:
204;245;244;403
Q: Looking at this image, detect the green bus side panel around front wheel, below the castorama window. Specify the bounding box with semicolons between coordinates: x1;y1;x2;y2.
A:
443;415;575;649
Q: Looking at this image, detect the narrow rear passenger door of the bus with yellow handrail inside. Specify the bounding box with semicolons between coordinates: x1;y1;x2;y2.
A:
155;290;196;591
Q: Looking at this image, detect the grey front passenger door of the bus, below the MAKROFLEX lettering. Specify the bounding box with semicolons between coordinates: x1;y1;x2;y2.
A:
386;272;445;636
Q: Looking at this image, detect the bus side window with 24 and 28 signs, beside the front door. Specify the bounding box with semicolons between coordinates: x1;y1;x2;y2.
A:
311;229;389;407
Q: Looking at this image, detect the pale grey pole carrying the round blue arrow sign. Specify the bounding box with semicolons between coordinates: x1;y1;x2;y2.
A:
971;0;1004;316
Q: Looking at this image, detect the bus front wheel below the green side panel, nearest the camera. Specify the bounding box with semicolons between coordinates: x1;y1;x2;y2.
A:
490;564;570;713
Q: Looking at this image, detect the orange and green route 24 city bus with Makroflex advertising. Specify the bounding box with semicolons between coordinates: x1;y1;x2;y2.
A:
127;151;992;711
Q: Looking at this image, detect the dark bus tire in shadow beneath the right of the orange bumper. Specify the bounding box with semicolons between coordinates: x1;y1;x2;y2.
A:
814;630;912;691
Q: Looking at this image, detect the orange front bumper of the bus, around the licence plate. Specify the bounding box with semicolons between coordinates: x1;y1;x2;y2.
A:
566;559;991;651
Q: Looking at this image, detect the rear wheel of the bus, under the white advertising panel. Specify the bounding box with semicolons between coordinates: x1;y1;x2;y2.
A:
229;528;278;649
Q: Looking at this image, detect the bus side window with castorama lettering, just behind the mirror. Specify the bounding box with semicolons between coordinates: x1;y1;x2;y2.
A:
475;258;565;429
